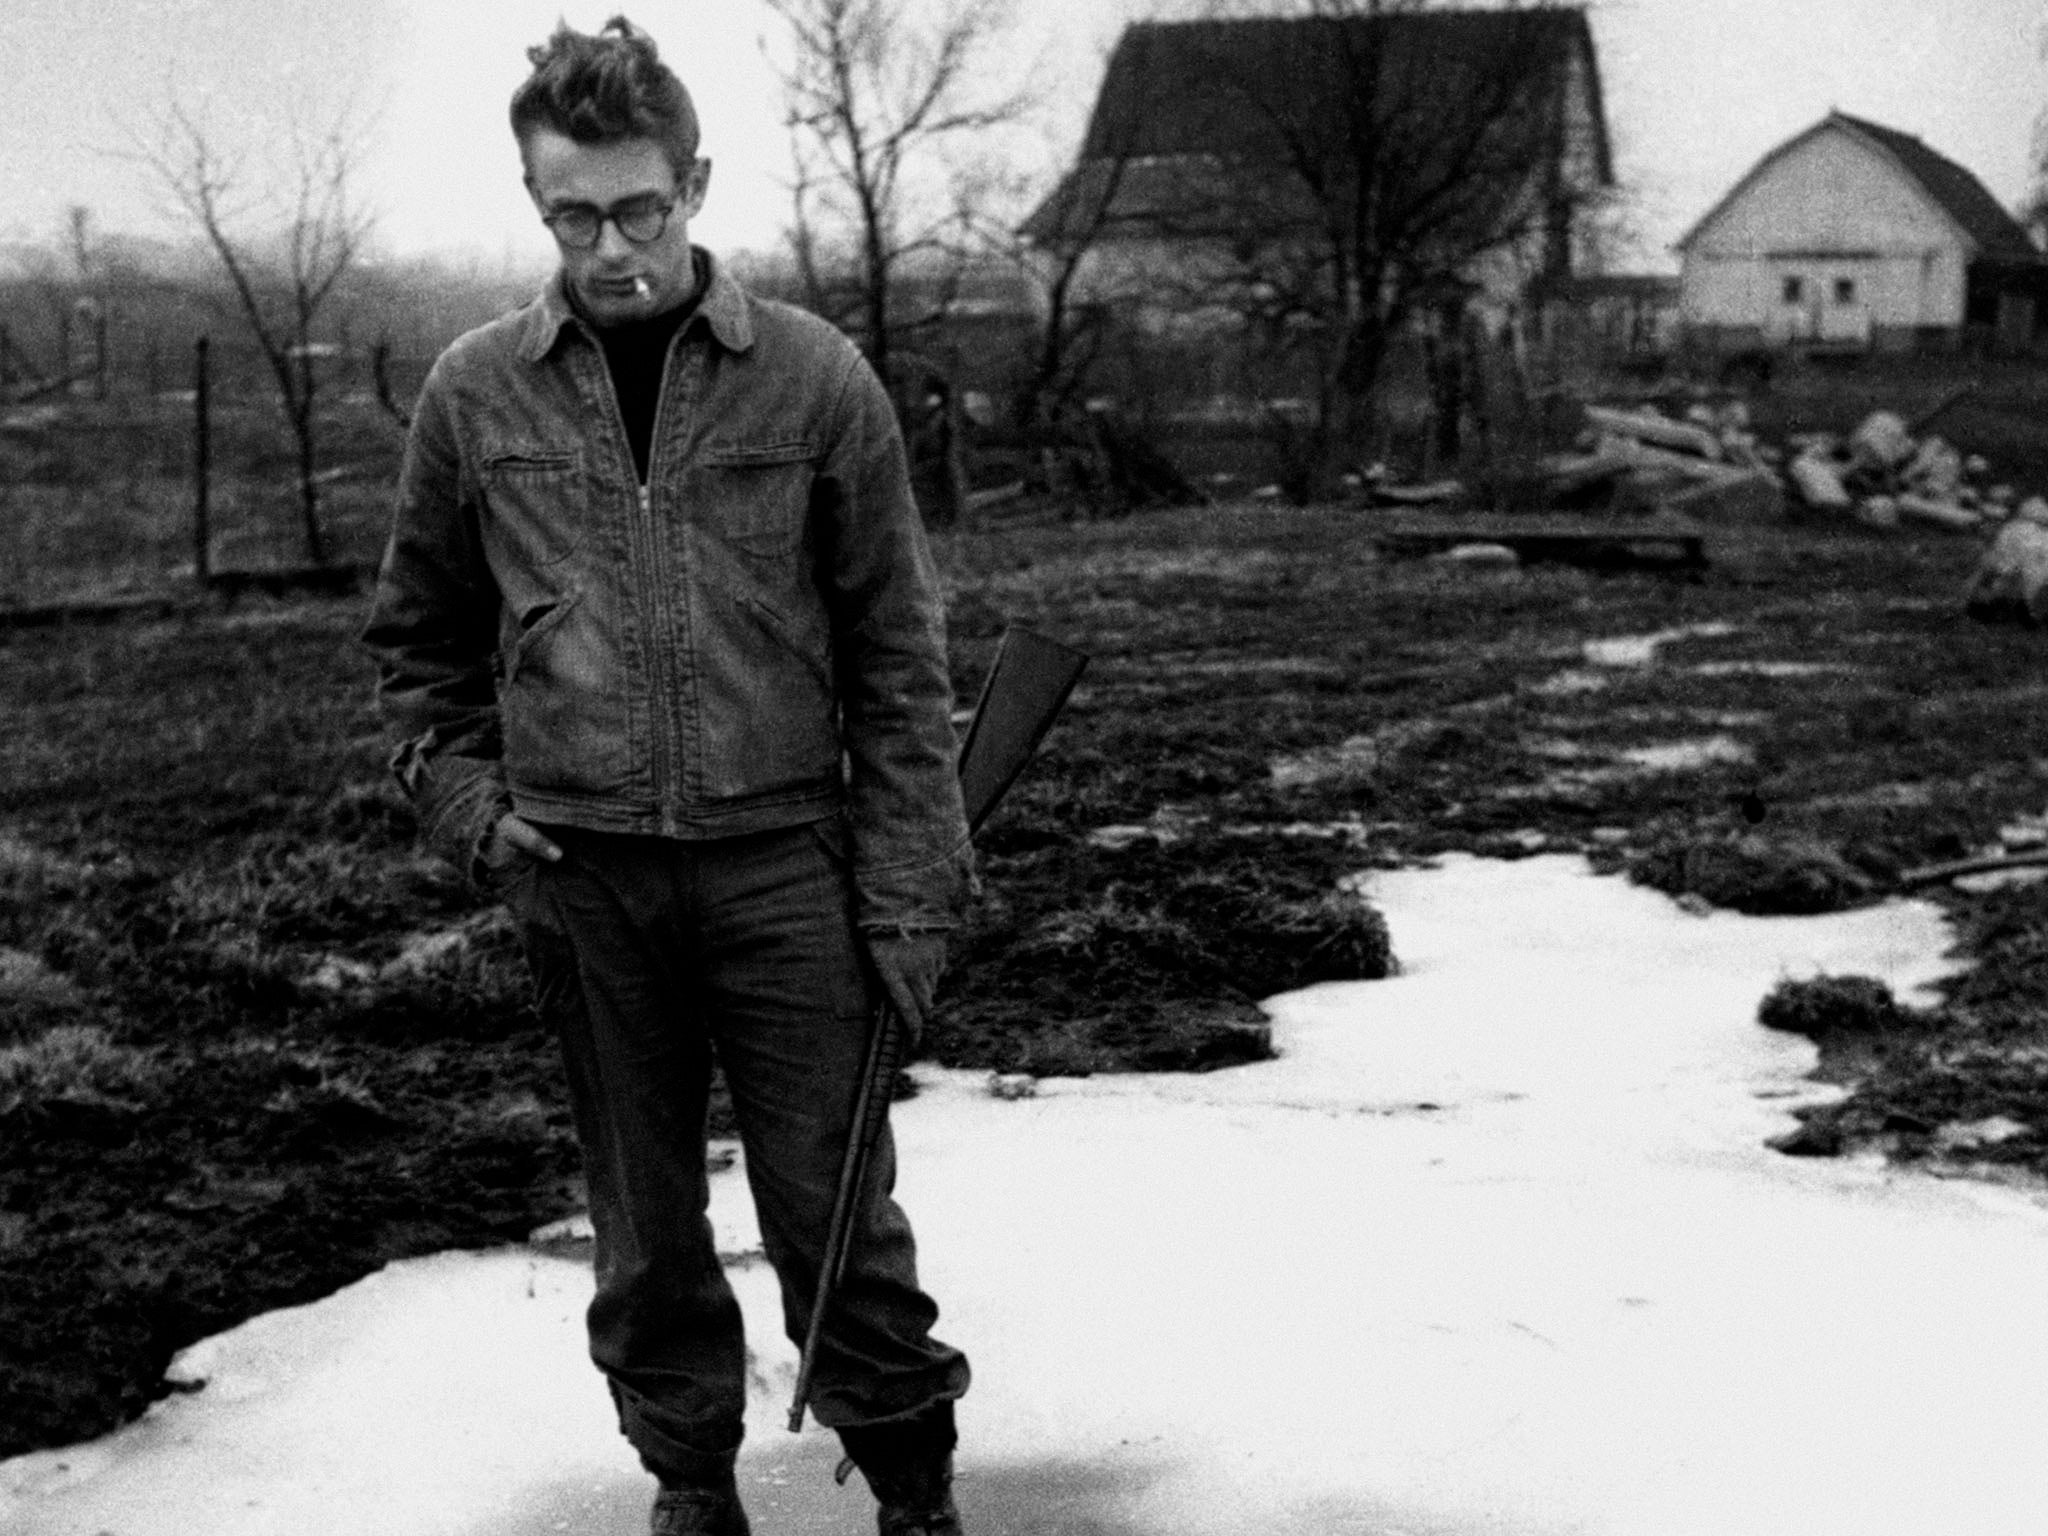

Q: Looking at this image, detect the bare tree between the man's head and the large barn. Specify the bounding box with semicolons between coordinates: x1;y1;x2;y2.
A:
768;0;1026;379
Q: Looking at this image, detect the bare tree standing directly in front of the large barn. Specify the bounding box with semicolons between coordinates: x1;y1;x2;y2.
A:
1092;0;1602;487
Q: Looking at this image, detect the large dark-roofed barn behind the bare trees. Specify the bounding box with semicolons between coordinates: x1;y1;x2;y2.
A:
1022;6;1614;328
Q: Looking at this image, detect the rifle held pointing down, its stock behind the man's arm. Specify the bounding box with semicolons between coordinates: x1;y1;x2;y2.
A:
788;627;1087;1434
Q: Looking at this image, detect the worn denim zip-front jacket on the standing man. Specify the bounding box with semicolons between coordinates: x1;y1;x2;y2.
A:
362;252;973;930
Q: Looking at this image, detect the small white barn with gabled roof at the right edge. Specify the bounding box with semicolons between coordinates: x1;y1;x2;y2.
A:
1677;113;2048;350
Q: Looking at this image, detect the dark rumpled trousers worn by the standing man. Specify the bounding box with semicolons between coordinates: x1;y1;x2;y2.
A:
510;819;969;1483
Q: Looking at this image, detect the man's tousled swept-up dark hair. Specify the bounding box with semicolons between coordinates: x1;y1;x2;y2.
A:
512;16;696;178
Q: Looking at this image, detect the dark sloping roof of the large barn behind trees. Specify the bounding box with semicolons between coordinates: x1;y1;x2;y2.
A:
1024;4;1614;242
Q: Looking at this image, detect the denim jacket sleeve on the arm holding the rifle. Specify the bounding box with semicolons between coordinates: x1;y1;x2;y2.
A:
815;354;975;932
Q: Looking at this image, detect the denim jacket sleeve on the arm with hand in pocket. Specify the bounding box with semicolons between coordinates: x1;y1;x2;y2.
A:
362;365;510;883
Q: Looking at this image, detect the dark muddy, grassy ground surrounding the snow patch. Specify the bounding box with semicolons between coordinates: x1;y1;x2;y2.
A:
0;506;2048;1456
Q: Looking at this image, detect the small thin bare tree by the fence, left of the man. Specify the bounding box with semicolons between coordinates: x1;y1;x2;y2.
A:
137;100;371;565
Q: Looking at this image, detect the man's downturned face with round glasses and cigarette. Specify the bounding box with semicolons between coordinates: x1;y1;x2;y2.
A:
522;129;711;326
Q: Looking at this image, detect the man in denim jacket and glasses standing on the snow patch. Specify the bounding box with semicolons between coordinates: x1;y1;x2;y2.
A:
365;18;971;1536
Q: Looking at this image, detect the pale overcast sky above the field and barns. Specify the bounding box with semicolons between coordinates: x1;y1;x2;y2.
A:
0;0;2048;266
